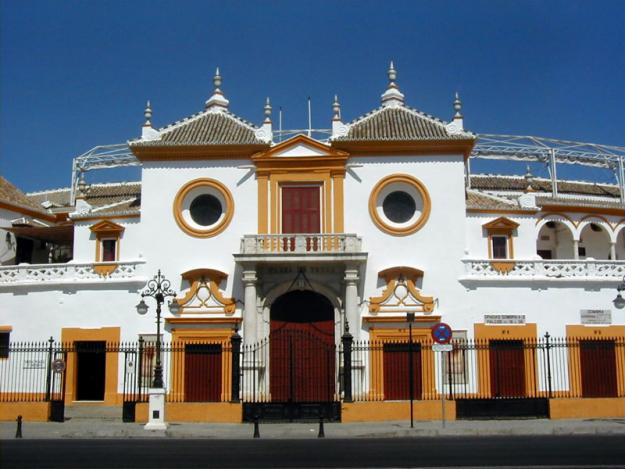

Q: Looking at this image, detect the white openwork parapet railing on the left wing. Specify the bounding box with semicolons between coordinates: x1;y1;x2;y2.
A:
0;261;145;287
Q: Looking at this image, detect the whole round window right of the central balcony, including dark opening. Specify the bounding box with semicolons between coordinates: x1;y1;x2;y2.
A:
369;174;430;236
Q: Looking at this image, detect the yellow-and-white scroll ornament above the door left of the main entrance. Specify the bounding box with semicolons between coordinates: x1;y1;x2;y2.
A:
177;269;236;314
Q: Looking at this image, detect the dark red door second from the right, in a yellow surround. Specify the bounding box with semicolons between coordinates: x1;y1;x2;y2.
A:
489;340;525;397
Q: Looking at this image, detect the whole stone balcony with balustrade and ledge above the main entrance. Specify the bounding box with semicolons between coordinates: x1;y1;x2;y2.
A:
235;233;367;261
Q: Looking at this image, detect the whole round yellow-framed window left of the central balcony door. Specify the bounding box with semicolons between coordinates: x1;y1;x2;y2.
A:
174;179;234;238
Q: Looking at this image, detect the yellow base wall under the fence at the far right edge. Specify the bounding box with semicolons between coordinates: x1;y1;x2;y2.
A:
549;397;625;419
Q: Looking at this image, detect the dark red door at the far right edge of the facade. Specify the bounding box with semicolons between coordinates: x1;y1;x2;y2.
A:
579;340;617;397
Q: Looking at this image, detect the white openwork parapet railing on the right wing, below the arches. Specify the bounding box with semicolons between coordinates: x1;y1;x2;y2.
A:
462;259;625;280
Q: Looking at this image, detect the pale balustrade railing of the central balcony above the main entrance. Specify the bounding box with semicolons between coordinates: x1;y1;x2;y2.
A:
241;233;362;254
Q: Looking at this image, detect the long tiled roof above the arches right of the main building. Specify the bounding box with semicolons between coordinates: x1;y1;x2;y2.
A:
471;175;619;197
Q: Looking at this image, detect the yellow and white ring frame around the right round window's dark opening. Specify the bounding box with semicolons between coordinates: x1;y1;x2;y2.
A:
369;174;432;236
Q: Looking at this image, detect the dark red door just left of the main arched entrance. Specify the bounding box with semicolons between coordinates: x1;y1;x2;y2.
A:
184;344;221;402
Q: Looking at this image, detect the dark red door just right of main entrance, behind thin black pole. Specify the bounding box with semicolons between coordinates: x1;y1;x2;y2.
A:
383;343;421;401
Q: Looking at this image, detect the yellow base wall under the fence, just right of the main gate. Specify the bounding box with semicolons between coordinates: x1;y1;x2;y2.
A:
341;401;456;423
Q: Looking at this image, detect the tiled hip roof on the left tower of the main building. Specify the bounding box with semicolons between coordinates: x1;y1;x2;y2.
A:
130;110;267;146
